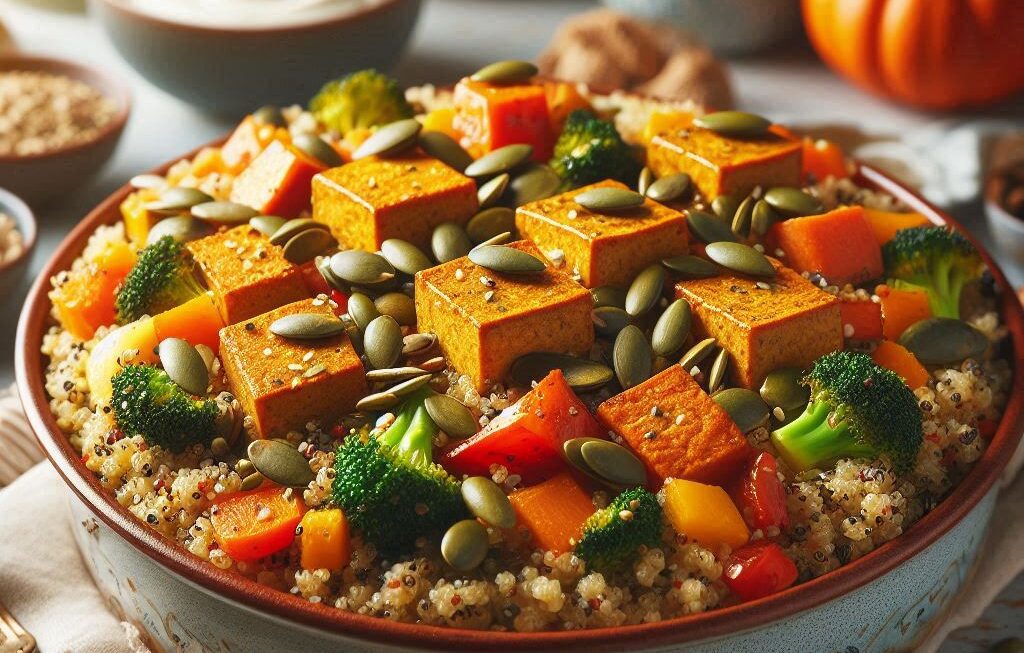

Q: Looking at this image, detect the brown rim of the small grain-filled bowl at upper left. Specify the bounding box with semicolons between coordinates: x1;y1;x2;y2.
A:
0;51;132;165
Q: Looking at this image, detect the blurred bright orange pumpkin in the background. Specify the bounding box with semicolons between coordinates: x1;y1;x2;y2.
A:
803;0;1024;108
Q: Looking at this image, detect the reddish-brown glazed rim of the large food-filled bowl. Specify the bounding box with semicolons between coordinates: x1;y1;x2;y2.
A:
15;147;1024;653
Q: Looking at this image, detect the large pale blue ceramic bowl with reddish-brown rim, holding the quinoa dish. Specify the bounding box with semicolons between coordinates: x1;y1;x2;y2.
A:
15;155;1024;653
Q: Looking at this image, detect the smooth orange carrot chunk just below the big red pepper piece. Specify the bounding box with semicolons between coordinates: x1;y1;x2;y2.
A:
509;472;594;553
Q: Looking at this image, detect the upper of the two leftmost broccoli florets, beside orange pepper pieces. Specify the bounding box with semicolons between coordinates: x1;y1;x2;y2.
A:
115;235;204;324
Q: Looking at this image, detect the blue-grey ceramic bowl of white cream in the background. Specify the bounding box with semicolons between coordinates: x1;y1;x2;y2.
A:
91;0;420;116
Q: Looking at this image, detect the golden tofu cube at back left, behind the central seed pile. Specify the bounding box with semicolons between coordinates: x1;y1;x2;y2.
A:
313;153;477;252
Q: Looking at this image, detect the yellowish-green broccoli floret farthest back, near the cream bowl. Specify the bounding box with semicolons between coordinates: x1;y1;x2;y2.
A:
309;70;413;136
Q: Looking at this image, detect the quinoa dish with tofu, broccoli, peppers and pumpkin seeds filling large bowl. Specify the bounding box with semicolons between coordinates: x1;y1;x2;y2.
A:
43;66;1011;632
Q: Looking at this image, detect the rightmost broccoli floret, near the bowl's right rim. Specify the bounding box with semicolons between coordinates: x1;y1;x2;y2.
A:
882;226;984;319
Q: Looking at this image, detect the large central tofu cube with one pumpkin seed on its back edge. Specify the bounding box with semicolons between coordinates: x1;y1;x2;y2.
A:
416;241;594;393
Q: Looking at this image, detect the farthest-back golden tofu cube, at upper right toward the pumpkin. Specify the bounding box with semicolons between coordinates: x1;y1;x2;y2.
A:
647;127;803;202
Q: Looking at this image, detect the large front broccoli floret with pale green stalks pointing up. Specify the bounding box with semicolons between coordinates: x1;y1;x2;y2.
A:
332;394;468;555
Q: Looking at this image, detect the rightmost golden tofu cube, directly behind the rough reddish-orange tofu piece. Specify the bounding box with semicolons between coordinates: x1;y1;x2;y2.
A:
676;259;843;389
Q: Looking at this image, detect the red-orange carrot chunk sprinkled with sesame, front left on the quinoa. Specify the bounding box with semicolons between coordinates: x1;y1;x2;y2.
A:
210;487;306;561
